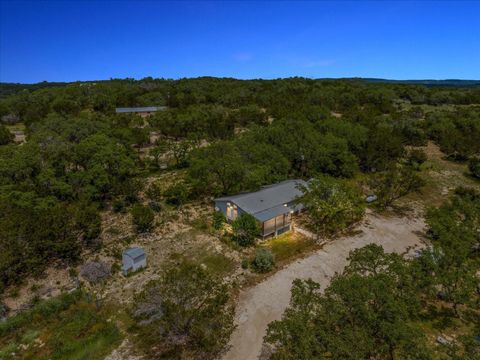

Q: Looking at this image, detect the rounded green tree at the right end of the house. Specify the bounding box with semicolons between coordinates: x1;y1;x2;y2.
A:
298;176;365;235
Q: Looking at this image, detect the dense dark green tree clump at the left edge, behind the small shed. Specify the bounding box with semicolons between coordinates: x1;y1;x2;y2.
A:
0;114;141;289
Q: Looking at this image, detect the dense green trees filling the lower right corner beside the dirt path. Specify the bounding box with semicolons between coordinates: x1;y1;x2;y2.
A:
265;189;480;359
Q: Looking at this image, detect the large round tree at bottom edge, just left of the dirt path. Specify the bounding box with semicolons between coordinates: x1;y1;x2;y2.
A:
133;263;235;359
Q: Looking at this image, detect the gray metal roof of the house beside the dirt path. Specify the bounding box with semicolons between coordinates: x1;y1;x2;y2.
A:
215;179;307;221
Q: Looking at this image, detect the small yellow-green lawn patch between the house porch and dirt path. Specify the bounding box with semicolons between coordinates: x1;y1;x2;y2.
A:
260;232;316;262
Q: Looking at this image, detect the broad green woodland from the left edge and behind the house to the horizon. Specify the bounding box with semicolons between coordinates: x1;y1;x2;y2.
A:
0;78;480;286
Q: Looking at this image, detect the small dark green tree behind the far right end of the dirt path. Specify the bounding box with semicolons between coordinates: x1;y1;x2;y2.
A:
370;164;425;208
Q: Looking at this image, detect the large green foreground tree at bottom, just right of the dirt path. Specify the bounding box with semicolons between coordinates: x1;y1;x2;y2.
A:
265;246;430;359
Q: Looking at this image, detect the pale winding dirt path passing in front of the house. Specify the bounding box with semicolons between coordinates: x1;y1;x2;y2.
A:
224;215;425;360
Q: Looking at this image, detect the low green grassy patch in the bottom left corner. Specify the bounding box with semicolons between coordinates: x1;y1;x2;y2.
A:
0;291;122;360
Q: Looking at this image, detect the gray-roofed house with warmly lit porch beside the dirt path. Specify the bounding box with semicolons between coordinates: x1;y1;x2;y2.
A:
215;180;307;238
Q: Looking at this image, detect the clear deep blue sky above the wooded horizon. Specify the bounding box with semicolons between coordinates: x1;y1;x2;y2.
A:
0;0;480;83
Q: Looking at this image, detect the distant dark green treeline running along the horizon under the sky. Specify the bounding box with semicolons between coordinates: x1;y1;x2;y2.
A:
0;77;480;122
